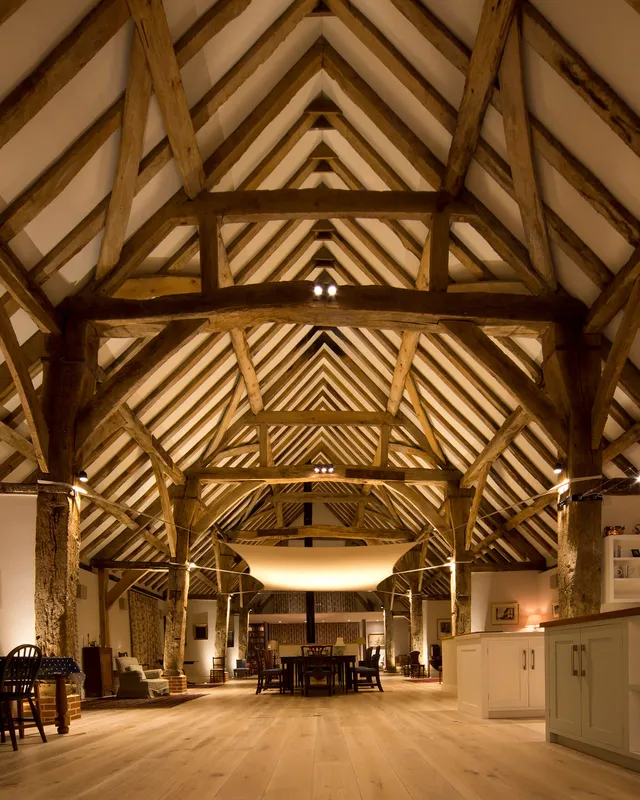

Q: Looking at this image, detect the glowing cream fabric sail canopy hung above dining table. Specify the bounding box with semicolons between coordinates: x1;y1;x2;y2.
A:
229;542;415;592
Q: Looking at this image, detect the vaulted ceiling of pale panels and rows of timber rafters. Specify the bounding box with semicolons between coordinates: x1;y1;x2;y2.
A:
0;0;640;594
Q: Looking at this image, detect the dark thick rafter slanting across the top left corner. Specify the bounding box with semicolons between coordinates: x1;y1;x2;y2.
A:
0;0;129;147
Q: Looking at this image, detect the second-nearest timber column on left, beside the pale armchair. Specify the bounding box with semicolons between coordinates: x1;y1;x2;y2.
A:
164;478;200;694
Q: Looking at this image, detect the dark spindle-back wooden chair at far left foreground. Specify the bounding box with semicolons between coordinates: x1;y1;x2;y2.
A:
0;644;47;750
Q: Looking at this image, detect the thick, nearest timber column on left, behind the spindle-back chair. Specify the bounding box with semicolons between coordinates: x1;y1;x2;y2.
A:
35;320;98;659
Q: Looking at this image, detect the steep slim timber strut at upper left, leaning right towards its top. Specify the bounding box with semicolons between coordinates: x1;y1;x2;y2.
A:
95;31;151;280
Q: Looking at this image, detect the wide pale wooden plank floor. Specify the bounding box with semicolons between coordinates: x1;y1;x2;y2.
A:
0;677;640;800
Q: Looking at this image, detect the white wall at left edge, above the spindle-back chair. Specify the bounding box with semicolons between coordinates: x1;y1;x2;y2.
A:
0;495;36;653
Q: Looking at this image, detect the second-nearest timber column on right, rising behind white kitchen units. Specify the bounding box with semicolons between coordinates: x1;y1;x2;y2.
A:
447;481;474;636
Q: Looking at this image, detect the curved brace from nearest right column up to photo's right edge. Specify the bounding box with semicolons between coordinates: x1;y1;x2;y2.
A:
591;278;640;450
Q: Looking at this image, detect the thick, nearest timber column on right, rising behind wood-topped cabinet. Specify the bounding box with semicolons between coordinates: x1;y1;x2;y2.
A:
554;326;602;617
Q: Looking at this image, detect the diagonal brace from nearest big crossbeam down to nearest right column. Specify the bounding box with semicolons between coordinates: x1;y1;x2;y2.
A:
441;321;567;453
